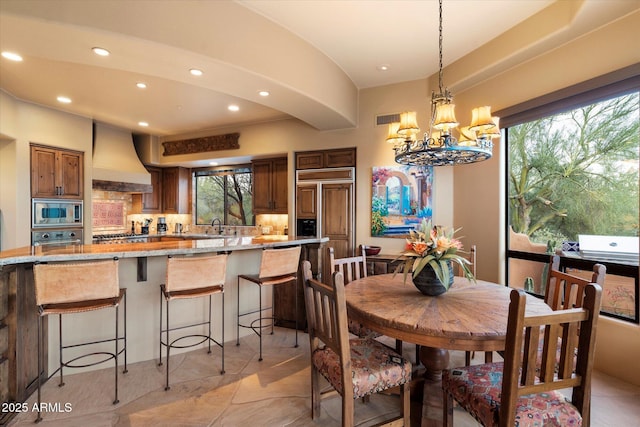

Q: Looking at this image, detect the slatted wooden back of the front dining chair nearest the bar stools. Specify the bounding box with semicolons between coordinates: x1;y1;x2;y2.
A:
302;261;353;401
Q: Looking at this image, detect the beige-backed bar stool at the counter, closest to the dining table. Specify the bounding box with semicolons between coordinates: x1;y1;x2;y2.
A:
236;246;300;362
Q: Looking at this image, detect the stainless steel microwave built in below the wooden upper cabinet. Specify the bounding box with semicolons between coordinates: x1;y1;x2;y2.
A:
31;199;82;228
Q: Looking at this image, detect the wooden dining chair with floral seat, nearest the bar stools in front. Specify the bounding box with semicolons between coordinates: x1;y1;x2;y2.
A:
302;261;411;426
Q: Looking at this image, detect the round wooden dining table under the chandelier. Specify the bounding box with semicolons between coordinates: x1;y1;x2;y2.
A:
345;274;551;377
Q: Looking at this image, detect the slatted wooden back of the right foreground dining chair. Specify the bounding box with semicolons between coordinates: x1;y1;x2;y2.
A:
499;283;602;426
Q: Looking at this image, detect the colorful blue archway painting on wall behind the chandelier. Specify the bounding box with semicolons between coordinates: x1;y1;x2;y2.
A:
371;166;433;237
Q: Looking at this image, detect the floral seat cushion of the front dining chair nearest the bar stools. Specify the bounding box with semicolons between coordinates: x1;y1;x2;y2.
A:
311;338;411;398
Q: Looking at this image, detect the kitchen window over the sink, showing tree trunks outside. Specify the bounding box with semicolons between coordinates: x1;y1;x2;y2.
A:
195;166;254;226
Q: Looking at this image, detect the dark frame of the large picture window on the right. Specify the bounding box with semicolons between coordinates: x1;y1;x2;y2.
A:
495;64;640;324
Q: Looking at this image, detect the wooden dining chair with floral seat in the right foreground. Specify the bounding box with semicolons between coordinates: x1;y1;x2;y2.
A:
442;283;602;427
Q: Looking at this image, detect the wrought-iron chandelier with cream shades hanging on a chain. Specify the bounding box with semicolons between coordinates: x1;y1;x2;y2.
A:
387;0;500;166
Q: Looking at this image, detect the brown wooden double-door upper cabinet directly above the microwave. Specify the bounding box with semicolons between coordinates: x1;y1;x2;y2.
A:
31;144;84;199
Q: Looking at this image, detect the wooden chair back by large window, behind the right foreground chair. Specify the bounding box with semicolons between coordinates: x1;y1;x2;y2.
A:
544;255;607;310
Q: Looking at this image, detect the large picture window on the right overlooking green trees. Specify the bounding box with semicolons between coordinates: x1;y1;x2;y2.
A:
502;70;640;323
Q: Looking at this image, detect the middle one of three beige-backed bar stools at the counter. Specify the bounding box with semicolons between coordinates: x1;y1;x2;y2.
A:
158;254;228;390
